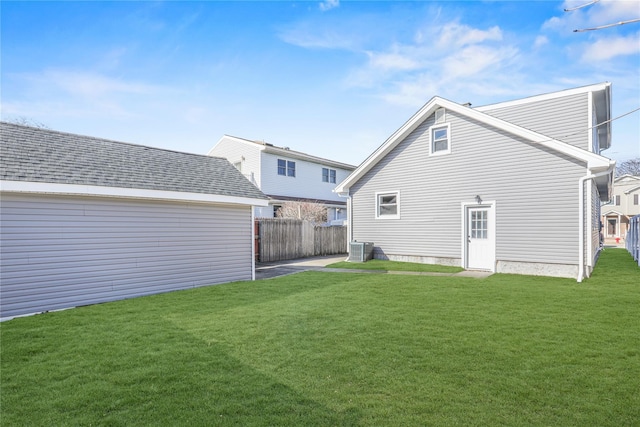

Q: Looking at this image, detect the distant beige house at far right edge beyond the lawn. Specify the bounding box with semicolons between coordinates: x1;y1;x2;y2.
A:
601;175;640;243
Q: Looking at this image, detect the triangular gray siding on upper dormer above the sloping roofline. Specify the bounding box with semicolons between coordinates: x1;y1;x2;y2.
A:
480;93;592;151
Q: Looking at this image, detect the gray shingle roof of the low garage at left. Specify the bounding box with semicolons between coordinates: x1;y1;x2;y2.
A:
0;122;266;199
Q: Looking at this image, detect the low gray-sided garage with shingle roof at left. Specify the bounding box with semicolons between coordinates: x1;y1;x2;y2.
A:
0;123;267;318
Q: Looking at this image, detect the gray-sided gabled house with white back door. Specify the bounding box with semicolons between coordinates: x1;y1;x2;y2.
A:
336;83;615;281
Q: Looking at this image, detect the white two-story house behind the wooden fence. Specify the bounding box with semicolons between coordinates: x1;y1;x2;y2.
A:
208;135;356;224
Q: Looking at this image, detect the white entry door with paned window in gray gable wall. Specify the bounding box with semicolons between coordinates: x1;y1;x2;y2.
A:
466;206;496;271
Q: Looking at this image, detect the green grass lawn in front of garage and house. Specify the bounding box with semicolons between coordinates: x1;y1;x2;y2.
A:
0;249;640;426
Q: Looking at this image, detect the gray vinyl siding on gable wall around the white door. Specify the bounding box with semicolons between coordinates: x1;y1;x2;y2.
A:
351;111;586;264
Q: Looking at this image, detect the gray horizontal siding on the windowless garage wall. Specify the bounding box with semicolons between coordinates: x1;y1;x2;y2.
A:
0;193;252;317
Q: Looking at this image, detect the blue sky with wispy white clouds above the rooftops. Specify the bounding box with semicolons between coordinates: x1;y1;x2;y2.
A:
0;0;640;165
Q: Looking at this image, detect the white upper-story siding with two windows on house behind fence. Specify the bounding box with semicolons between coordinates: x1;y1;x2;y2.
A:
261;153;350;203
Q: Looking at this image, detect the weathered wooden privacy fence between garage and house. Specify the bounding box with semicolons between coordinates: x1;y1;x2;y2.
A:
256;218;347;262
